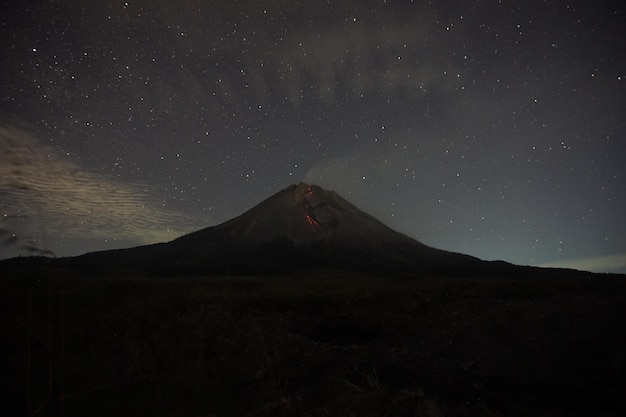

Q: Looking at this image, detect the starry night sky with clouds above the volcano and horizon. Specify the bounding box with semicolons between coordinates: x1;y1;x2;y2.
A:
0;0;626;272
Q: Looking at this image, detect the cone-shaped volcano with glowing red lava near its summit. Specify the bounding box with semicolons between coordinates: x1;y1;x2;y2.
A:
18;182;488;275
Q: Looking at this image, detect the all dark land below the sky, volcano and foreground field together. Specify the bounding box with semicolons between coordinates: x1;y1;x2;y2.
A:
0;183;626;417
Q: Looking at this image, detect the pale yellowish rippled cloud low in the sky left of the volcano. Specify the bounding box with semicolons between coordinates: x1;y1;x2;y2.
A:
0;125;200;255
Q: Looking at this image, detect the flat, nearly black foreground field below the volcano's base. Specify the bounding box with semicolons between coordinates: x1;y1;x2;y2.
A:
0;269;626;417
